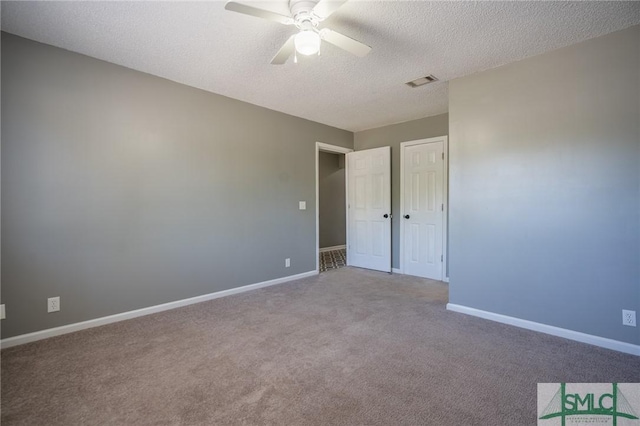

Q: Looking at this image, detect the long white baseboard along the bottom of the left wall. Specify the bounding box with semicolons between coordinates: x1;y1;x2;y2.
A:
0;271;318;349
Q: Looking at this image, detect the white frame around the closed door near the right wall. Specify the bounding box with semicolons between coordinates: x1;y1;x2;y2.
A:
399;136;449;282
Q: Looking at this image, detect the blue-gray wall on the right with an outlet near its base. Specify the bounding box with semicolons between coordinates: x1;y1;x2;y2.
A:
449;27;640;344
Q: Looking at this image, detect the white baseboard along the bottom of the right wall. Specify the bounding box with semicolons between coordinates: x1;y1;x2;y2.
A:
447;303;640;356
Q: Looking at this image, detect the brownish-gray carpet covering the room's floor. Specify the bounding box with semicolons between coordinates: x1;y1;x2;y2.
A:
1;267;640;426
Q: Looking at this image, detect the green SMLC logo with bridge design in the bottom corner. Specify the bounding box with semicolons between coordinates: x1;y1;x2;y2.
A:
539;383;638;426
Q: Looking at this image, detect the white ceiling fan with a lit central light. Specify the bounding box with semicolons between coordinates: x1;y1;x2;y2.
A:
224;0;371;65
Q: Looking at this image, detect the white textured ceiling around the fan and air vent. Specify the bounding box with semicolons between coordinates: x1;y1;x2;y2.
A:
2;0;640;131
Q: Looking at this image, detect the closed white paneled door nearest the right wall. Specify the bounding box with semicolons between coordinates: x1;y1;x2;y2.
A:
400;138;445;280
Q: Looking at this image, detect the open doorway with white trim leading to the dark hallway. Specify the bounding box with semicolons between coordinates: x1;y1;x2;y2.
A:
316;142;353;272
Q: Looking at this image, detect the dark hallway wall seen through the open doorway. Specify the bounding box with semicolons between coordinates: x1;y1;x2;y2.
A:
318;152;347;248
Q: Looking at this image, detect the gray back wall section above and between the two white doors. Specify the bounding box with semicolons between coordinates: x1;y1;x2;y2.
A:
353;115;449;268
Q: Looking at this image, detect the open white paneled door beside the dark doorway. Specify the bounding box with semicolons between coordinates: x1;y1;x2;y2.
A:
347;146;391;272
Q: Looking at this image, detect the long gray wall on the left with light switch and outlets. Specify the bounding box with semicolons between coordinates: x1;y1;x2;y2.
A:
2;33;353;338
